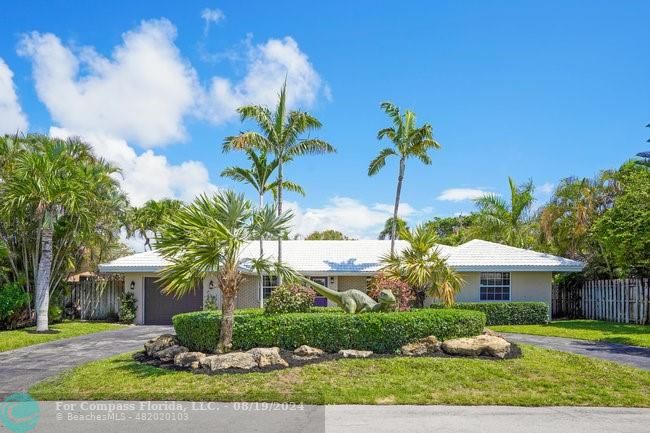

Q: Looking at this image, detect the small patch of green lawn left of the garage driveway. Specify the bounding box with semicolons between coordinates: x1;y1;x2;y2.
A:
0;321;124;352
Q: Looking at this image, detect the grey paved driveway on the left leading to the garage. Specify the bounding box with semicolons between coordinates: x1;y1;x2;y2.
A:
0;326;172;399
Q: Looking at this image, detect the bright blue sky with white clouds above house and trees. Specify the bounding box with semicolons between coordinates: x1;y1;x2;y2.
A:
0;1;650;237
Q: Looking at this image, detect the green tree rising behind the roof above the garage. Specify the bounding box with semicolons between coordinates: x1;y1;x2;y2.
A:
125;199;183;251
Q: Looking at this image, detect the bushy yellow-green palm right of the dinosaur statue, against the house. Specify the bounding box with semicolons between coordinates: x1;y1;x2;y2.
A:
382;225;464;307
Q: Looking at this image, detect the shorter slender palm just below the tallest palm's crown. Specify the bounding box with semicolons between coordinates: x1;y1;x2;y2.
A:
221;148;305;307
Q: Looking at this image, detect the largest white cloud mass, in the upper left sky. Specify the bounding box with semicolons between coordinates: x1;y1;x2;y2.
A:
18;20;321;205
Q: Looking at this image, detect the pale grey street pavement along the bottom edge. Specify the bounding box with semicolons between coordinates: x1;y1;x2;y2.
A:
19;401;650;433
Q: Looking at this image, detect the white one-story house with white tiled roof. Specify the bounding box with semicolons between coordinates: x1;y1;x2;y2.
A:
99;240;583;324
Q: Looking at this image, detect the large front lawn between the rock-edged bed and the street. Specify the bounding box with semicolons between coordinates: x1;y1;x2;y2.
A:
29;345;650;407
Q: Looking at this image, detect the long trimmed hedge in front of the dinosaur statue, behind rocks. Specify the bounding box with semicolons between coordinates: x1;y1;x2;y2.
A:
172;308;485;353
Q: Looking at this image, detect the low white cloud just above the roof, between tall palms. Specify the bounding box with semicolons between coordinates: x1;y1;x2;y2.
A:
286;197;418;239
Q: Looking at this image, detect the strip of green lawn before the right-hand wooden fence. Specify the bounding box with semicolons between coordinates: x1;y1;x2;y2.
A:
490;320;650;347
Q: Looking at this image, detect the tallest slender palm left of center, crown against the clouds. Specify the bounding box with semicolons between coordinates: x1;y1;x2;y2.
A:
223;81;336;263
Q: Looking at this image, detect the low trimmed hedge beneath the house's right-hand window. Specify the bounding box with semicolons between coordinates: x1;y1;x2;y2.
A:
431;302;549;326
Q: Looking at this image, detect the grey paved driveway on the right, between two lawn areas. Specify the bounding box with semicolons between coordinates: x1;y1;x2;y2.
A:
501;332;650;370
